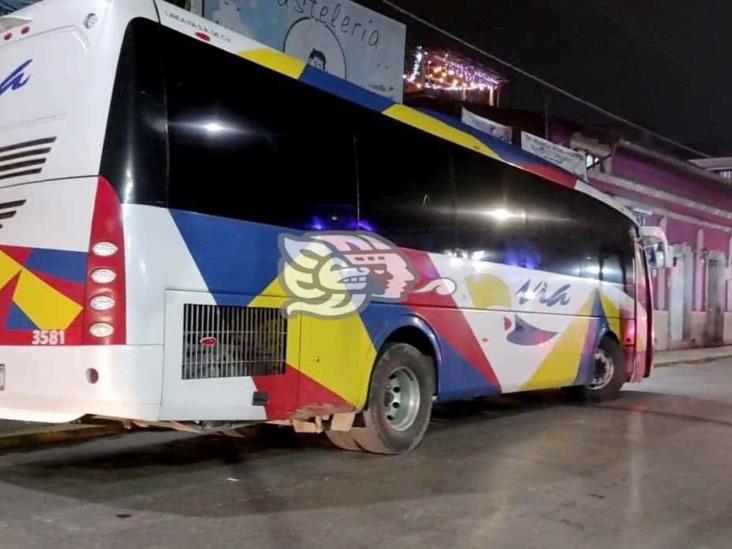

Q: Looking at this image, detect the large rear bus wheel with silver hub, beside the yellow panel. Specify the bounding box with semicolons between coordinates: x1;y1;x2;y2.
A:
350;343;435;454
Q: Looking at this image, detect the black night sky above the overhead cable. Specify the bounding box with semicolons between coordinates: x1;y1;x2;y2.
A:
380;0;732;156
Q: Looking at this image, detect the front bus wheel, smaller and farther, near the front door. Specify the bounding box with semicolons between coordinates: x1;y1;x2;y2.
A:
569;337;627;402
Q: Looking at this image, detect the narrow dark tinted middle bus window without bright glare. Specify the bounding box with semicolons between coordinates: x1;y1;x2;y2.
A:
357;116;455;253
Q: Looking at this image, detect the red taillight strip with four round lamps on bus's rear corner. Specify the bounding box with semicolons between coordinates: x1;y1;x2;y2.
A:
84;178;126;345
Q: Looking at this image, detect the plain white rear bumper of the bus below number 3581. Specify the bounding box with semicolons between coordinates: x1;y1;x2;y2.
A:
0;345;163;423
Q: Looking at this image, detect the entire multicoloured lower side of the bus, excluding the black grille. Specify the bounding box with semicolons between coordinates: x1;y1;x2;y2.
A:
157;206;634;419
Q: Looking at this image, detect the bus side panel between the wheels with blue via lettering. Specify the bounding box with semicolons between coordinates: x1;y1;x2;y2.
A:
394;252;634;399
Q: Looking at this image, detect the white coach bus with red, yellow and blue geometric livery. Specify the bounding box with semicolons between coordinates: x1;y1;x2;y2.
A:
0;0;667;454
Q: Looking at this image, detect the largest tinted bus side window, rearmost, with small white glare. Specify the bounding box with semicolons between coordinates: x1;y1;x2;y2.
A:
166;25;356;230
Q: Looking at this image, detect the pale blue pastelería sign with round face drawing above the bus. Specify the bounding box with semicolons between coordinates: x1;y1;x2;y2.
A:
203;0;406;101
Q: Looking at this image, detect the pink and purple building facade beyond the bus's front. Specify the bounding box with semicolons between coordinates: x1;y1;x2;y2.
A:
571;136;732;349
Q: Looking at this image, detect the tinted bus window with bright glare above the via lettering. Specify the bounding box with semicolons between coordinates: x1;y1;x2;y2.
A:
452;148;633;289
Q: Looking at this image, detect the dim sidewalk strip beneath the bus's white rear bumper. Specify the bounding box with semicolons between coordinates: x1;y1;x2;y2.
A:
0;419;124;451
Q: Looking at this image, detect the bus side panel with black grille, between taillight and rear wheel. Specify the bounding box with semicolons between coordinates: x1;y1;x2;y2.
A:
149;209;375;420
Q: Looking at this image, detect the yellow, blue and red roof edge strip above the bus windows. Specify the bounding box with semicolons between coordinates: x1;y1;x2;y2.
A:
160;2;636;223
